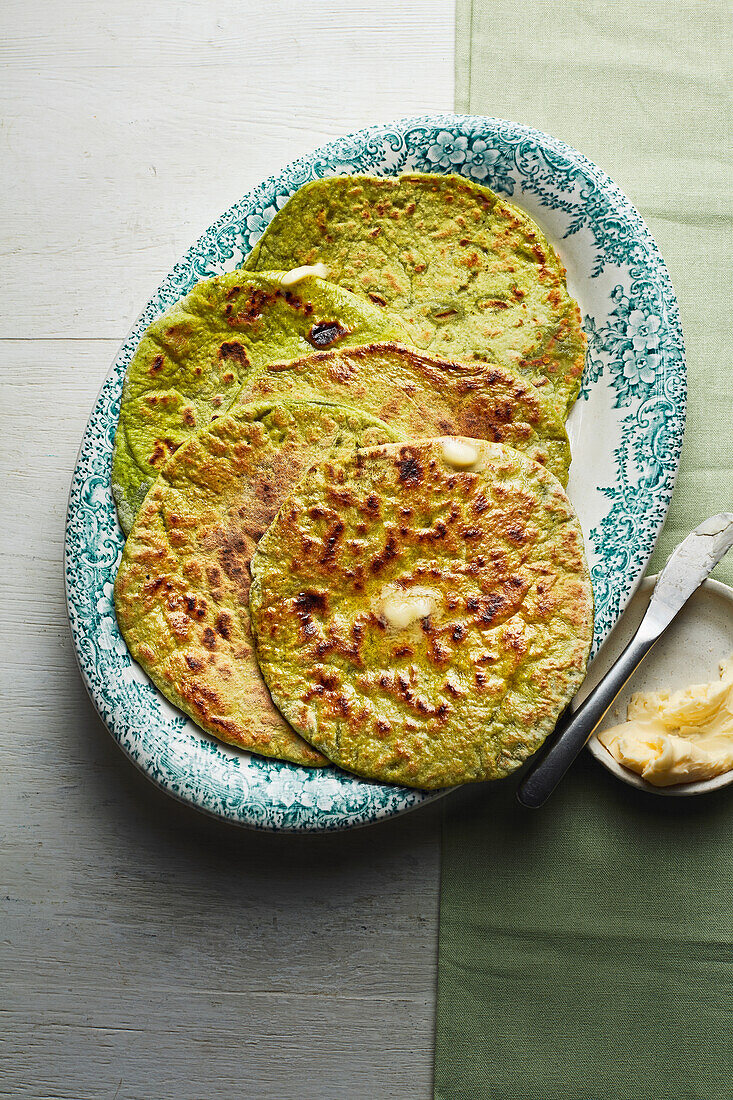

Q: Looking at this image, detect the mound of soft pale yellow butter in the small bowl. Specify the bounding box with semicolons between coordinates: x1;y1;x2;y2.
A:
598;657;733;787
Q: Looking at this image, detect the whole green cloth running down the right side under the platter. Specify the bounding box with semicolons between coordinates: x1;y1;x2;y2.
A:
435;0;733;1100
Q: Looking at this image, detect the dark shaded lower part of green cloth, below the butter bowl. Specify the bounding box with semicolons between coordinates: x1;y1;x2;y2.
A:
435;755;733;1100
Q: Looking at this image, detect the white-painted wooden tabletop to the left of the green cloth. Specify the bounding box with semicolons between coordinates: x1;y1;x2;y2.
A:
0;0;453;1100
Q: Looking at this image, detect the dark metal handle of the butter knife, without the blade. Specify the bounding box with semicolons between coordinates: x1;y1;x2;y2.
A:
516;624;659;809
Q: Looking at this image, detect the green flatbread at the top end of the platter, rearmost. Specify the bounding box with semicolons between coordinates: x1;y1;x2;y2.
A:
245;174;586;416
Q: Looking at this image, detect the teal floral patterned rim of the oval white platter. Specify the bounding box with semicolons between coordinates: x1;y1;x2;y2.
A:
65;114;686;831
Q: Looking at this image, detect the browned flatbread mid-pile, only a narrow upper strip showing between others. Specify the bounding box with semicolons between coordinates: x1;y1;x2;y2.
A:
238;343;570;485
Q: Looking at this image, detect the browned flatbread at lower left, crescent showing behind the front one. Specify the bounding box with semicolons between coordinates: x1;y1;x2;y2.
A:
114;402;398;766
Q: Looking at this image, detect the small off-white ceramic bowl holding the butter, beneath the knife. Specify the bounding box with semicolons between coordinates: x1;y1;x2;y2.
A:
578;576;733;798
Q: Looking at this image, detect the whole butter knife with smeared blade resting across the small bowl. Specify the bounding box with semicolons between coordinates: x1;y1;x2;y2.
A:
516;512;733;809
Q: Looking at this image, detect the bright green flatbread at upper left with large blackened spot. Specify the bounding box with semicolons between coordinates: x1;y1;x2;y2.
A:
112;271;405;534
